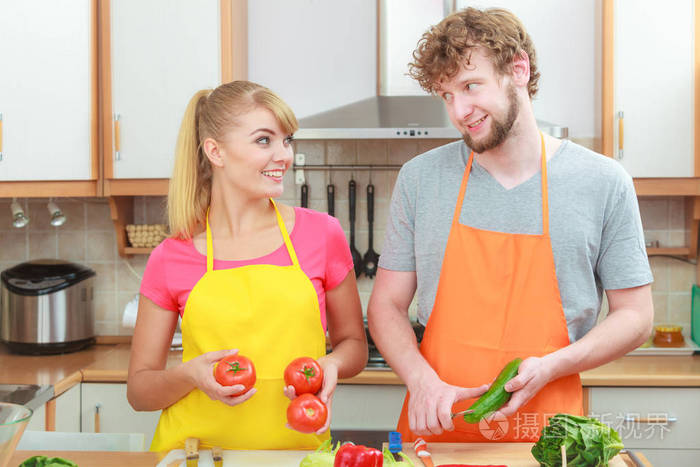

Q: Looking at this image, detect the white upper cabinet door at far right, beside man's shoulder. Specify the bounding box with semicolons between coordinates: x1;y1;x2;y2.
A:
614;0;696;177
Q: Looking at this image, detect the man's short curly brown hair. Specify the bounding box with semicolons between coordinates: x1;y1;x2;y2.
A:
408;7;540;98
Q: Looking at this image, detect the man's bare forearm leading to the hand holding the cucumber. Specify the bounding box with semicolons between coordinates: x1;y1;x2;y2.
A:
544;309;650;380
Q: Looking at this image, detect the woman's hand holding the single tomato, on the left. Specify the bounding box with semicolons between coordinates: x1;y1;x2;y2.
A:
184;349;256;406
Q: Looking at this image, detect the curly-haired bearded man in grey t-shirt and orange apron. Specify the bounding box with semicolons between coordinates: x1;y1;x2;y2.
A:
368;8;653;442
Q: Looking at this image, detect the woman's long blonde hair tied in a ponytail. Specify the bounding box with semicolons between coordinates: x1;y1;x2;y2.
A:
168;81;299;240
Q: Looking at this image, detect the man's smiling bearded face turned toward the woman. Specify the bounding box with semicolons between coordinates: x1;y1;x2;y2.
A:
438;48;520;153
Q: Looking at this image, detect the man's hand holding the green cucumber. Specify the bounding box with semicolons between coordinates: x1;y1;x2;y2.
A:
499;354;552;417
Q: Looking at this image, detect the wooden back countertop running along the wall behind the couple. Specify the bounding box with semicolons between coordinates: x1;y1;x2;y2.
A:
0;344;700;395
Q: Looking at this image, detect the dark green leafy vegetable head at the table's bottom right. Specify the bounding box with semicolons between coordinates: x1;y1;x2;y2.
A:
531;414;624;467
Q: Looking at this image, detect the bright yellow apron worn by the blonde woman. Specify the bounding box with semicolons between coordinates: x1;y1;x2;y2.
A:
151;199;330;451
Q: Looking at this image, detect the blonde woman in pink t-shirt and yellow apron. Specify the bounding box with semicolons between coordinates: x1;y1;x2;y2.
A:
127;81;367;451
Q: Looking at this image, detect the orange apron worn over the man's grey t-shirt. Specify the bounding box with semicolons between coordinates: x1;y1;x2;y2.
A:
397;136;583;442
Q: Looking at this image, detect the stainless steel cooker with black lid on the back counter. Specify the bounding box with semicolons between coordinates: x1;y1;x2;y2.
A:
0;259;95;354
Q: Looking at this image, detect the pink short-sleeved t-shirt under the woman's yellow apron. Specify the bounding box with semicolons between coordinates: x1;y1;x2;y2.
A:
141;207;353;329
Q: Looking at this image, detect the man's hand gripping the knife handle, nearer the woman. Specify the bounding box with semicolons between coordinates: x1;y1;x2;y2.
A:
408;376;489;435
